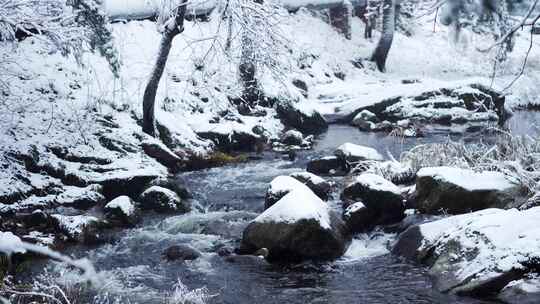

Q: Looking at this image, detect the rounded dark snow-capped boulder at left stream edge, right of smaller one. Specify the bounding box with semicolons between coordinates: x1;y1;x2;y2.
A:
140;186;190;213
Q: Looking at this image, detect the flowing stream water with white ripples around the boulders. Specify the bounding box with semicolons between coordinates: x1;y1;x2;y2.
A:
27;111;540;304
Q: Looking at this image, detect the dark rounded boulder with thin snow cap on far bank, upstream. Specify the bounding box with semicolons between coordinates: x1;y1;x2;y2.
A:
276;101;328;134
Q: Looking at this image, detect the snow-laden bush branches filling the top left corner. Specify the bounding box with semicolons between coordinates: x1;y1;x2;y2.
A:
0;0;120;75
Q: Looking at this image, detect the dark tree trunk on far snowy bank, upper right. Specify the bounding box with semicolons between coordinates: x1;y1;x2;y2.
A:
371;0;396;72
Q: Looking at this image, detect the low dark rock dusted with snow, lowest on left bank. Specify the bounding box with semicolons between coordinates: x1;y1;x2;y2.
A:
51;214;107;244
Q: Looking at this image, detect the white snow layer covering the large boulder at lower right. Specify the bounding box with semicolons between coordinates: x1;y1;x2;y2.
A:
420;207;540;279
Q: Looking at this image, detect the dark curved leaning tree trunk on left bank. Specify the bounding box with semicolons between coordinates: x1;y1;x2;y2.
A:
143;0;187;136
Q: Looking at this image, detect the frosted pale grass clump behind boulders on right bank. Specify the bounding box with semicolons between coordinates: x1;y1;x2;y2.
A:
401;131;540;193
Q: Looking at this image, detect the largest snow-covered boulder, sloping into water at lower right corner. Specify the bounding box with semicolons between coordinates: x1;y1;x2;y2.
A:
393;207;540;296
